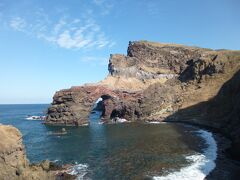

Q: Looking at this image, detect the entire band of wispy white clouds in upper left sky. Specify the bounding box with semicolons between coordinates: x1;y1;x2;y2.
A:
9;12;114;49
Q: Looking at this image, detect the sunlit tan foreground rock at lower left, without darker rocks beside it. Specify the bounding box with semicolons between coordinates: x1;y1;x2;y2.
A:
0;125;55;180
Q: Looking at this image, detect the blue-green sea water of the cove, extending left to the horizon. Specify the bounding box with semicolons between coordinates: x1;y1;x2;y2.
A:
0;105;216;179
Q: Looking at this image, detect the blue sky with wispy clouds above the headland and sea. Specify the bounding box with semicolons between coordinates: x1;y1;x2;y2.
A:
0;0;240;104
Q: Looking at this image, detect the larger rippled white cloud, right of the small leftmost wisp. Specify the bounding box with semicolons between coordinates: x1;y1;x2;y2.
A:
42;19;113;49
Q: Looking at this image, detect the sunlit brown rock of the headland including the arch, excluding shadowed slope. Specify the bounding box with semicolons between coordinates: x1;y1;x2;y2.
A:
45;41;240;125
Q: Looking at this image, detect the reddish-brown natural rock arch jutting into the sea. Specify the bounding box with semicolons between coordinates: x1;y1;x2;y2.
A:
45;85;140;126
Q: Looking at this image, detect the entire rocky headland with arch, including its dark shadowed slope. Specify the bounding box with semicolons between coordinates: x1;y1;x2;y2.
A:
45;41;240;159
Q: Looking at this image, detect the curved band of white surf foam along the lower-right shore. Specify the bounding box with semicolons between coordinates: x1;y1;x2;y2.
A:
153;130;217;180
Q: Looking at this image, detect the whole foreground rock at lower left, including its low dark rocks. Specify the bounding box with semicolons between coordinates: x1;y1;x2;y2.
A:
0;124;76;180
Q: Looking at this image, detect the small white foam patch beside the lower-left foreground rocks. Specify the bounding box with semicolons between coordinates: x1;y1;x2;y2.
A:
67;164;88;180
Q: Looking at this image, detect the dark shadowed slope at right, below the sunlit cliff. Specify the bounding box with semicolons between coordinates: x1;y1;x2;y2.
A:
167;70;240;160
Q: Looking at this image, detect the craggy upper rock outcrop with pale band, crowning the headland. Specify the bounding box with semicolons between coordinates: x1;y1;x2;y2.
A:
109;42;202;76
